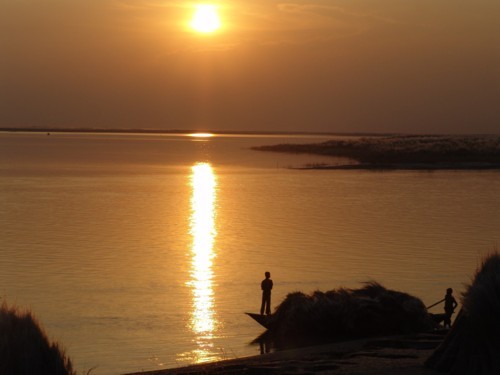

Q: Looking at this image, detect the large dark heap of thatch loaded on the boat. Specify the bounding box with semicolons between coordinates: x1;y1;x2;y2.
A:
266;282;435;342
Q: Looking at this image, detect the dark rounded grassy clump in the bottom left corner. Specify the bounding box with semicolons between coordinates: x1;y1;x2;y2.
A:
0;303;75;375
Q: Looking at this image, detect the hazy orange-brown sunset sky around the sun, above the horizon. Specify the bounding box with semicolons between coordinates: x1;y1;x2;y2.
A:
0;0;500;133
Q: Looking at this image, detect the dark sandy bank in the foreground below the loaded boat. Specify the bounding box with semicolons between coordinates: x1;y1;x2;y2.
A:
128;332;444;375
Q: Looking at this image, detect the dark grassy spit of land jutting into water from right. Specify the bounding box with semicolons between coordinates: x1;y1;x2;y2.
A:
252;135;500;169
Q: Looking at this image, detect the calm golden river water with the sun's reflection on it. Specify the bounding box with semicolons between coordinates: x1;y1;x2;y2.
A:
0;133;500;375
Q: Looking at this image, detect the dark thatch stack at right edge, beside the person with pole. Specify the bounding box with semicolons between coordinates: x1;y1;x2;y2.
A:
426;254;500;375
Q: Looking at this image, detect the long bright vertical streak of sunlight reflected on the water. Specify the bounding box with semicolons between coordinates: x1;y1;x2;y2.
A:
182;163;217;363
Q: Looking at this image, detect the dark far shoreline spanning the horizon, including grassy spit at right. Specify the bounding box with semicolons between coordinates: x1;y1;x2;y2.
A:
4;127;500;171
